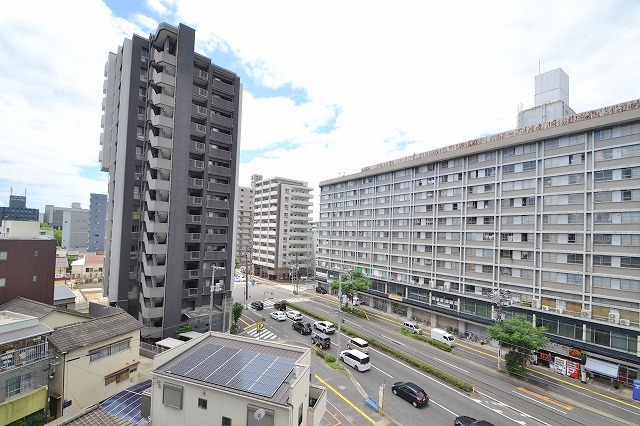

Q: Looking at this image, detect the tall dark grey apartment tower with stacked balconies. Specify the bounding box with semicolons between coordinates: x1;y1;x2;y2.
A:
100;24;242;340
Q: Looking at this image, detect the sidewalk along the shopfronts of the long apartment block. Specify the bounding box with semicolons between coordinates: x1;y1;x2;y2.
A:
352;305;640;406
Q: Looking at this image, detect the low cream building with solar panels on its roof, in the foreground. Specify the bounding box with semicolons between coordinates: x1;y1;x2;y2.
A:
149;332;327;426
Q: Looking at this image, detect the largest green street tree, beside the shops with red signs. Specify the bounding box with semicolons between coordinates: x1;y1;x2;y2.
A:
487;317;549;377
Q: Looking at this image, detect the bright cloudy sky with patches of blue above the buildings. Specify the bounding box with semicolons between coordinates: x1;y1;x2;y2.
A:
0;0;640;216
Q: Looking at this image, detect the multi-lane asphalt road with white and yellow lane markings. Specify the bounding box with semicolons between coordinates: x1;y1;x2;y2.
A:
238;284;640;426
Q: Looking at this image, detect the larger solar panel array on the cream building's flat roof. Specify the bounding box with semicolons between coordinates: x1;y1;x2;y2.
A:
167;344;294;397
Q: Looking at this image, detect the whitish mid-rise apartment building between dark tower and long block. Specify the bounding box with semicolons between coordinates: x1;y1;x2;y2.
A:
252;175;313;283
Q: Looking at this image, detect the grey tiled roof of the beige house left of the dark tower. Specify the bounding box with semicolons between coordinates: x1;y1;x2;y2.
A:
49;311;142;353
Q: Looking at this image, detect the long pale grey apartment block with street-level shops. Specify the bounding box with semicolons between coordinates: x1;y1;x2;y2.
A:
317;91;640;382
